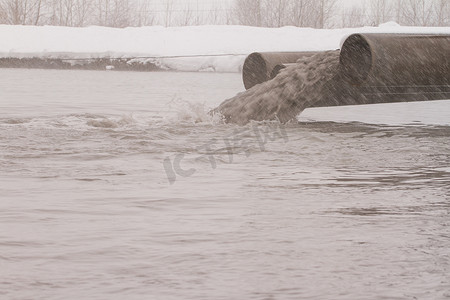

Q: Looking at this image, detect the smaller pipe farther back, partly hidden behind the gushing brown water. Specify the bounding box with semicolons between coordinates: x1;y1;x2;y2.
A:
242;52;317;90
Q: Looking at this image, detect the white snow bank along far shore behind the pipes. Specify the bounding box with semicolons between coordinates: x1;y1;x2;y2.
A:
0;23;450;72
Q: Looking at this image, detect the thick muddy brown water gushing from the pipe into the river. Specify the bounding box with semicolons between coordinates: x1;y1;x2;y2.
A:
213;51;339;125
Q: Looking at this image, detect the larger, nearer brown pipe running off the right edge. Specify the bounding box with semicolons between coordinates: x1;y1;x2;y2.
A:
340;33;450;87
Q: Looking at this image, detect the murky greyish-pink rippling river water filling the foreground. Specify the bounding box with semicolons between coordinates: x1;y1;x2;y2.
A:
0;69;450;300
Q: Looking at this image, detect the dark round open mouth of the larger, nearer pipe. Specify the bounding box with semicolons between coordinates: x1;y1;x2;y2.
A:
340;34;373;85
